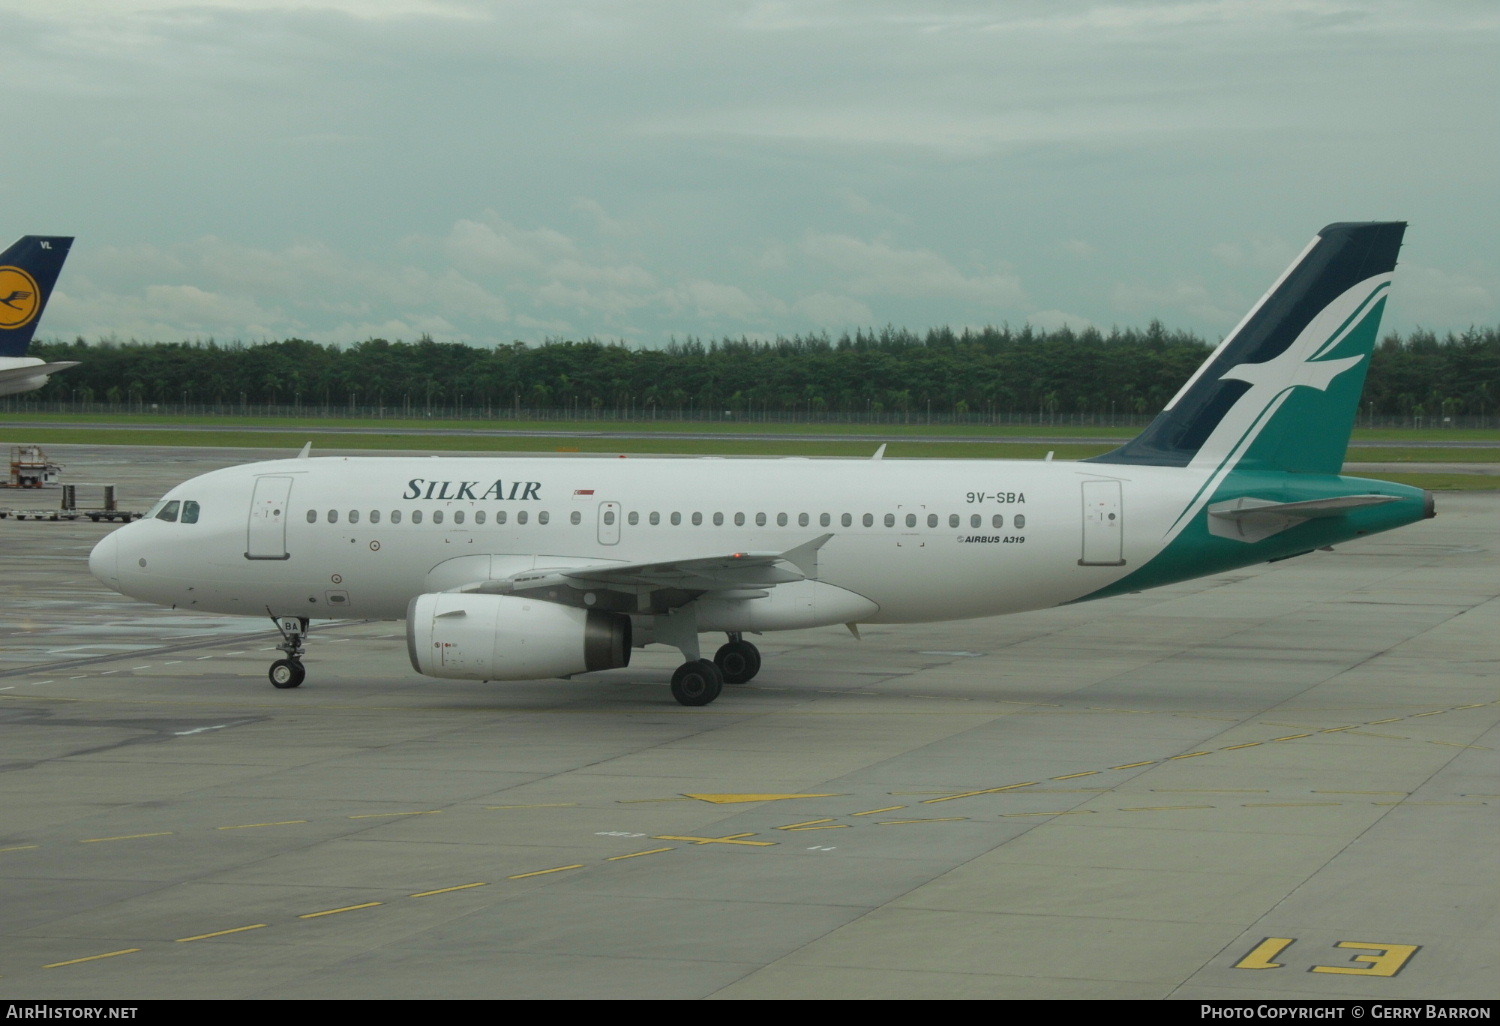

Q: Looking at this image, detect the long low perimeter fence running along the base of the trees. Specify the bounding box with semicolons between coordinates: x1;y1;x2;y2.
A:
0;393;1500;431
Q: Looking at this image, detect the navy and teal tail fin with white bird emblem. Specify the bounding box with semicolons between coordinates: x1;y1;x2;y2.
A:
1091;221;1406;476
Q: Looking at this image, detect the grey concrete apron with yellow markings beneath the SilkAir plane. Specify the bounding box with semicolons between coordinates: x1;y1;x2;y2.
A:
0;446;1500;1002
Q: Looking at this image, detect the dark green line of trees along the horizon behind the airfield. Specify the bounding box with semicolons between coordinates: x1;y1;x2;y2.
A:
15;321;1500;420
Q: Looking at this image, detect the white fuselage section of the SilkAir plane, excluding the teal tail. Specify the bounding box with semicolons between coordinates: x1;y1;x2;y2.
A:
90;456;1208;630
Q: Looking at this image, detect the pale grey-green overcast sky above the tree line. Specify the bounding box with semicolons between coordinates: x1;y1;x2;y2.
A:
0;0;1500;345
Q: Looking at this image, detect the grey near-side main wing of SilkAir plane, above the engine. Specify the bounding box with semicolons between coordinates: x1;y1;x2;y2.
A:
474;534;833;594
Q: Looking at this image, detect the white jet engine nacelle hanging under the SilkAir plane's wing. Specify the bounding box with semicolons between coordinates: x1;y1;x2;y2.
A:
407;591;630;681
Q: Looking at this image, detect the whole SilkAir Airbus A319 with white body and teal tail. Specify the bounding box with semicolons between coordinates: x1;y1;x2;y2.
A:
89;224;1433;705
